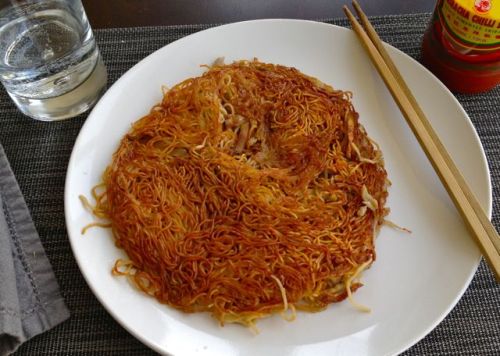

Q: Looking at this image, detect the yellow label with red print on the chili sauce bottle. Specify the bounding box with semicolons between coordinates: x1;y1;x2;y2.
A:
437;0;500;51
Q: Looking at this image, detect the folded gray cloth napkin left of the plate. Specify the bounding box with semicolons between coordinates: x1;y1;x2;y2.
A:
0;145;69;356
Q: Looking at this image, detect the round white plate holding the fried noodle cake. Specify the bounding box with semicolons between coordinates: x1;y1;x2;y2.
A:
65;20;491;355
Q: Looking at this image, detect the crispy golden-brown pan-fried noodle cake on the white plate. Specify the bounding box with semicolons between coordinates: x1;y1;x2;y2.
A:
84;60;388;327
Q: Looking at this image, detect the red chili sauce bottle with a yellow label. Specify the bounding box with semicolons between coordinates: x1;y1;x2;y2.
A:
422;0;500;93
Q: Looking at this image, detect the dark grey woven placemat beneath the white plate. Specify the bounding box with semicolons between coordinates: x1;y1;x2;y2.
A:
0;14;500;355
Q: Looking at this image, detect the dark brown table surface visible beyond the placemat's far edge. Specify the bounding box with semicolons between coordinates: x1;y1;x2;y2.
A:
83;0;436;28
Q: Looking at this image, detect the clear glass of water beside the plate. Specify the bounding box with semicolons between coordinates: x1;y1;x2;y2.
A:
0;0;107;121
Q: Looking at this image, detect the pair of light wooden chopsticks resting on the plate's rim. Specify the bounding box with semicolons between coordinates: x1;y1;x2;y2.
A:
344;0;500;282
